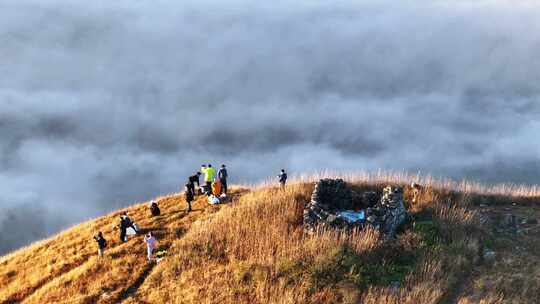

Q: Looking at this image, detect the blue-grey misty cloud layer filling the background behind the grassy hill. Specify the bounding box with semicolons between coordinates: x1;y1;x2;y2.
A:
0;0;540;254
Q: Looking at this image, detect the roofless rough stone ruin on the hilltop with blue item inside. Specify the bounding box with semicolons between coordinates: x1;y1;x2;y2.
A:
304;179;407;238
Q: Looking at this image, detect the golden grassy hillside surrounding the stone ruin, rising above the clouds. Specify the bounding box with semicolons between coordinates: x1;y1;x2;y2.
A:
0;174;540;304
